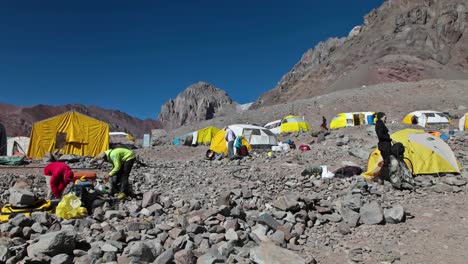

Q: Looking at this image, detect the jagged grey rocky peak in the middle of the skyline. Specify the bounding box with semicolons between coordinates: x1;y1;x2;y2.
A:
158;82;235;129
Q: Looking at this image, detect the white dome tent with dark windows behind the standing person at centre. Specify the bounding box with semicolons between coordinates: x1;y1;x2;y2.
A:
229;124;278;148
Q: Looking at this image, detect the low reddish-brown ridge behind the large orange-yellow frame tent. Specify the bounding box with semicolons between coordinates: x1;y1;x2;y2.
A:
0;103;162;137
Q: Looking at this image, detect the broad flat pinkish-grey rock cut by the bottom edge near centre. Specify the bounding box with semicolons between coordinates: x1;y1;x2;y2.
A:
250;242;306;264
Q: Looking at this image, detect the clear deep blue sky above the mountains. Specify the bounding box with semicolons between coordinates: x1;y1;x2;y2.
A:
0;0;383;119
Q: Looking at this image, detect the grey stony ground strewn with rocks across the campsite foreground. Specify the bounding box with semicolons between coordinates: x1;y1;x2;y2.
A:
0;121;468;263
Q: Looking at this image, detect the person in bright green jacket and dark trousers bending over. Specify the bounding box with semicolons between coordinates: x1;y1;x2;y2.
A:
97;148;136;199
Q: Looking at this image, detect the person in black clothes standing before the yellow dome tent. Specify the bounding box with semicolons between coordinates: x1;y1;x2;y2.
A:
375;112;392;183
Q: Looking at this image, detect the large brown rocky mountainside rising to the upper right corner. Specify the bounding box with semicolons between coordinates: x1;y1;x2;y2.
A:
252;0;468;108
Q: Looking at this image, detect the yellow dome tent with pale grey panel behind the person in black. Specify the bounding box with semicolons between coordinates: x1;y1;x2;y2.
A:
363;128;460;178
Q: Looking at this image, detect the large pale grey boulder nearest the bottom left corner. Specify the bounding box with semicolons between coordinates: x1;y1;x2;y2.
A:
27;231;76;258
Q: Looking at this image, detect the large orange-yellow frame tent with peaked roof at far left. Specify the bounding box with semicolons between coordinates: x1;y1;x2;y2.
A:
28;111;109;158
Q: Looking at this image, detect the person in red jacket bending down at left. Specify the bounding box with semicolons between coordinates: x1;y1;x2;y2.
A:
44;162;73;199
